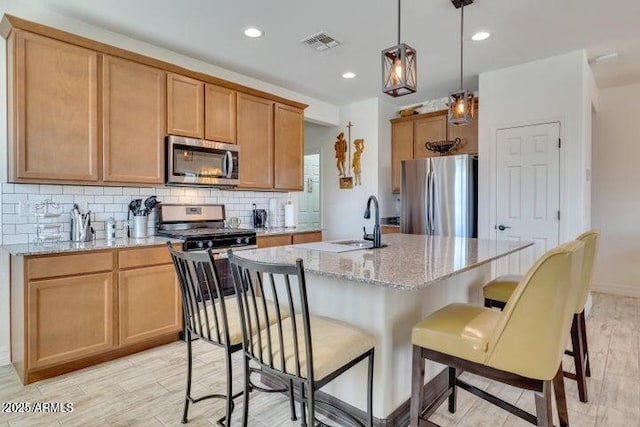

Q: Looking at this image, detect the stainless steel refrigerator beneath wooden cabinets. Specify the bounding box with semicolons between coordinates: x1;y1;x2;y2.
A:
400;155;478;237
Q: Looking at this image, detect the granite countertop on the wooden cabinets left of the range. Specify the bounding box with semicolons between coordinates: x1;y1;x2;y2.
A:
2;236;182;256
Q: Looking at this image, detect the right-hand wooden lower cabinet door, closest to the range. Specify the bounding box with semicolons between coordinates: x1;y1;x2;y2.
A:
118;264;182;345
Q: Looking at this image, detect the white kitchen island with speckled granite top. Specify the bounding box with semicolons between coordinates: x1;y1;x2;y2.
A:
232;234;533;426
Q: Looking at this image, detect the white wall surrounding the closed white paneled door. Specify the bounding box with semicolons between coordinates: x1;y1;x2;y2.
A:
478;51;594;241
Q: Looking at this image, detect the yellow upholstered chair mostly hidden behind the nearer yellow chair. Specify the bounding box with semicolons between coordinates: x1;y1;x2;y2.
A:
482;230;600;402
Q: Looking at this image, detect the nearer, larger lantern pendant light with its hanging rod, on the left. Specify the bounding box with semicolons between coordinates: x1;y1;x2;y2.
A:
382;0;418;98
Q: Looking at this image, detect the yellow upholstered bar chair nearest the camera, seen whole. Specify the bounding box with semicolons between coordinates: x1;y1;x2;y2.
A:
410;241;584;427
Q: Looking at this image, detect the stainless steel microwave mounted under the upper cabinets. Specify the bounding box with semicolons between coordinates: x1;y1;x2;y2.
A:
166;135;239;187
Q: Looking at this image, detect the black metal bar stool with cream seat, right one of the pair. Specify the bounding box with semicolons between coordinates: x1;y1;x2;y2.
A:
228;251;376;427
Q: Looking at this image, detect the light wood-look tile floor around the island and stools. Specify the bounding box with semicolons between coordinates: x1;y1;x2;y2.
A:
0;293;640;427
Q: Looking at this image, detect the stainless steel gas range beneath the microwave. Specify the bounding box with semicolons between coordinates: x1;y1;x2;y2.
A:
156;204;257;295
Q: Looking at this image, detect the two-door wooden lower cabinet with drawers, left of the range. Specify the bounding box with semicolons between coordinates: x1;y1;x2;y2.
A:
10;245;182;384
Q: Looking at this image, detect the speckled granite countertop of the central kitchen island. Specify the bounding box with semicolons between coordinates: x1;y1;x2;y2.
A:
228;234;533;290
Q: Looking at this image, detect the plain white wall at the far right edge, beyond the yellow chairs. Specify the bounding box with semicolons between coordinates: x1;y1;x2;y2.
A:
592;84;640;297
